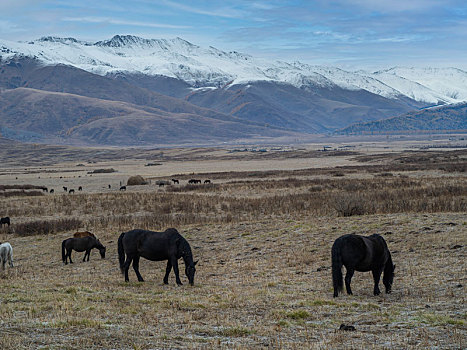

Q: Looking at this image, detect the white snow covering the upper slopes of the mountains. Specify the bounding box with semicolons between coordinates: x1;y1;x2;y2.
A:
0;35;467;104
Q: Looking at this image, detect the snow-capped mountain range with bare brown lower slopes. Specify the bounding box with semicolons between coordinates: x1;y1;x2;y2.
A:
0;35;467;145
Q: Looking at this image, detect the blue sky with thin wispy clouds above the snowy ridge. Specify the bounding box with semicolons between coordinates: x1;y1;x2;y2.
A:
0;0;467;69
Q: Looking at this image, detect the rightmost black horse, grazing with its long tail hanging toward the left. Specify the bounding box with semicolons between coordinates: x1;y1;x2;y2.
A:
331;234;396;297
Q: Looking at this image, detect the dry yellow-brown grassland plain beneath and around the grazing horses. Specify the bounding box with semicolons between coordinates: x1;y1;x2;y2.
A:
0;146;467;349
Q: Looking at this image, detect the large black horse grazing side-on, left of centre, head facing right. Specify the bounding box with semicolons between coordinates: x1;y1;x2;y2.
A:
118;228;197;285
